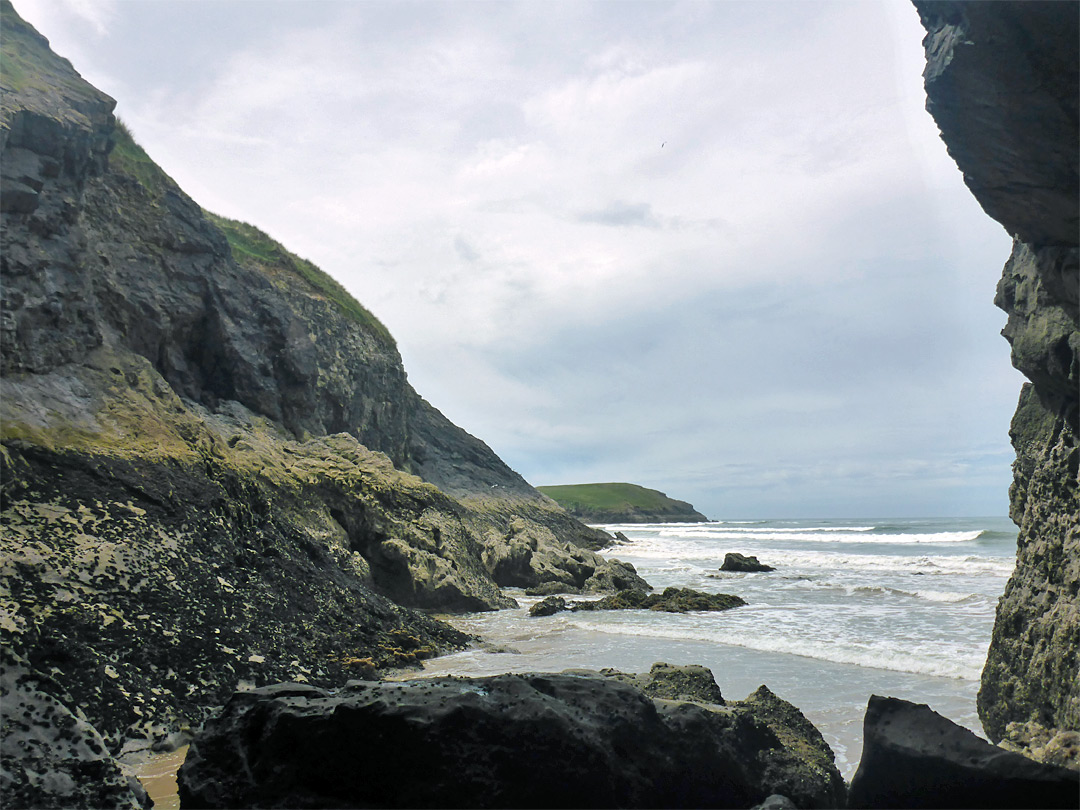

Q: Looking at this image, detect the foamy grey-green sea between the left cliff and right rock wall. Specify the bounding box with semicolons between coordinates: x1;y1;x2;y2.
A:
411;517;1016;780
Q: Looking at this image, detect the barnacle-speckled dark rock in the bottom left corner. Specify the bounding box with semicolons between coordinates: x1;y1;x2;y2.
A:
0;650;150;810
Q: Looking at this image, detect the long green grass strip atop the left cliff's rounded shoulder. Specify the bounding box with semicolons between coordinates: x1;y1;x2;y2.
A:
203;210;396;348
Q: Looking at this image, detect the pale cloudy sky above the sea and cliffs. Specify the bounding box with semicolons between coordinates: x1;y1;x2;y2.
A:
15;0;1023;519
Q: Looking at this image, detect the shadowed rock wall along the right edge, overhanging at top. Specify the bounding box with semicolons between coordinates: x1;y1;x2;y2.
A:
915;0;1080;760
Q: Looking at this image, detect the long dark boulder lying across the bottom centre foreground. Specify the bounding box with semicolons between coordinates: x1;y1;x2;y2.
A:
179;672;843;808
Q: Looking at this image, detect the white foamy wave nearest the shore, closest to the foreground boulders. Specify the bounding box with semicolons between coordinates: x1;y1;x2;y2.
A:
573;621;986;680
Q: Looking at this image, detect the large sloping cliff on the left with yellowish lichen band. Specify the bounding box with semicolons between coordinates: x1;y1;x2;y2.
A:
0;1;648;804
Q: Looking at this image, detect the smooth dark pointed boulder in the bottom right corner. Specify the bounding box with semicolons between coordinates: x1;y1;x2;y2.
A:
848;696;1080;808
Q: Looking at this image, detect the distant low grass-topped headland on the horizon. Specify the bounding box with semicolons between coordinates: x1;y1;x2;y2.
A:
537;484;708;524
